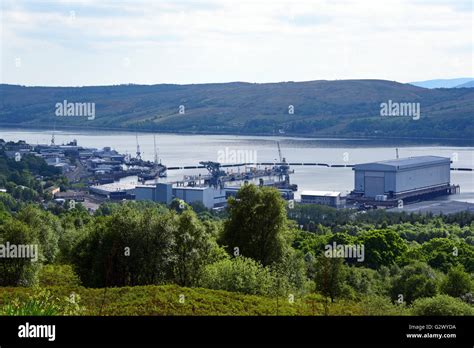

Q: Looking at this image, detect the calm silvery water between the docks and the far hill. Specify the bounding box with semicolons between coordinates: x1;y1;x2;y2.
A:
0;128;474;202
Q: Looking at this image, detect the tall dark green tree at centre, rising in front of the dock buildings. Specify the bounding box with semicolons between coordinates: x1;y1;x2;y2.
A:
221;185;291;266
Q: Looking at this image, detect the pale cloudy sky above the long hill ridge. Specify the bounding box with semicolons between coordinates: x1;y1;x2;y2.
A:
0;0;474;86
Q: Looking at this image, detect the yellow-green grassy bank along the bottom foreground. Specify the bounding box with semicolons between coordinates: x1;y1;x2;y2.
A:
0;285;374;316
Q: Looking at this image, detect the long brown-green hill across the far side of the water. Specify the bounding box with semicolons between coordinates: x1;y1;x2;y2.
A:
0;80;474;139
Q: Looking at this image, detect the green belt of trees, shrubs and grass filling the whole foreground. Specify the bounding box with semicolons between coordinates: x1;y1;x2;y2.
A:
0;185;474;315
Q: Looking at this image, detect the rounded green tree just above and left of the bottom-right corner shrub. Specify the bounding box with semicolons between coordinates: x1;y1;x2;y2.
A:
390;262;438;304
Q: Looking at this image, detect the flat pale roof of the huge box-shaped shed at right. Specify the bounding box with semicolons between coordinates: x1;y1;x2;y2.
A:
354;156;451;171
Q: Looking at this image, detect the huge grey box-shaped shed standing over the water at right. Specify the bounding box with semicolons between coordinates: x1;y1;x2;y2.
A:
352;156;451;198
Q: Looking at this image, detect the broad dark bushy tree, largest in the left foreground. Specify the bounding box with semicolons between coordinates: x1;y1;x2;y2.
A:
71;205;177;287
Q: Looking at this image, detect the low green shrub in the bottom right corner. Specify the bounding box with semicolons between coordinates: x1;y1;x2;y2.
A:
412;295;474;315
